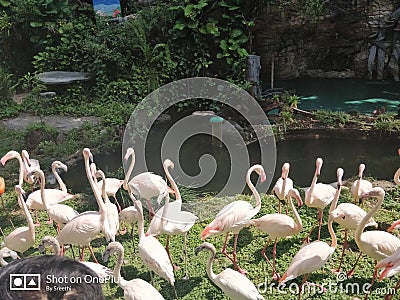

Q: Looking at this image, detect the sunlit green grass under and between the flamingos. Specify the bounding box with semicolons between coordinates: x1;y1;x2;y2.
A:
0;186;400;299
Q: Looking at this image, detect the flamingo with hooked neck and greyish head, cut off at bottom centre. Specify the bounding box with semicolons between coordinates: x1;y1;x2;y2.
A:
194;242;264;300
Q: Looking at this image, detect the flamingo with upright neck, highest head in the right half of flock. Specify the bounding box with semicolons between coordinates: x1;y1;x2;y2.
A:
304;157;336;241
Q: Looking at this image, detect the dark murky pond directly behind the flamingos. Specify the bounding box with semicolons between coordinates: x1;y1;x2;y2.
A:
63;135;400;192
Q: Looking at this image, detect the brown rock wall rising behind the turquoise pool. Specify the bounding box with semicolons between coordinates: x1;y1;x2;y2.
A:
254;0;400;82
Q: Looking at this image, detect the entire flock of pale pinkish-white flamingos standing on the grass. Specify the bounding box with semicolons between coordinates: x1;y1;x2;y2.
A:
0;148;400;300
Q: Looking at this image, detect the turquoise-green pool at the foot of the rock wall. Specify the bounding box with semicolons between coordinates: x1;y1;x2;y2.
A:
275;78;400;114
